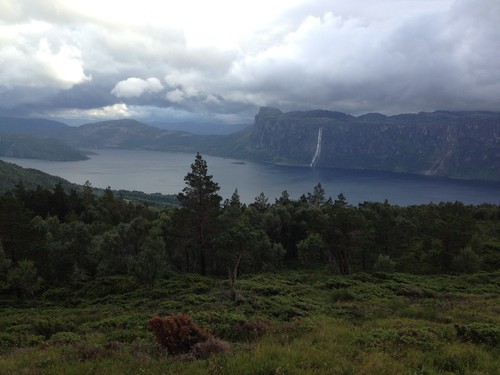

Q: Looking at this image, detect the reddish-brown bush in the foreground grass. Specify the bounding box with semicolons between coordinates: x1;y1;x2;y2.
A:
149;314;212;354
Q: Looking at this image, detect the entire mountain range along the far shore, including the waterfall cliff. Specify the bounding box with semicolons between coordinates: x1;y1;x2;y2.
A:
0;108;500;181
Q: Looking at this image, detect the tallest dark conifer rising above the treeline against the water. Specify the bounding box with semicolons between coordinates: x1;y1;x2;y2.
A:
177;153;222;275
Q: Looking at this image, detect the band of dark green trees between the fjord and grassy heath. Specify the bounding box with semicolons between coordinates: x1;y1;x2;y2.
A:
0;154;500;296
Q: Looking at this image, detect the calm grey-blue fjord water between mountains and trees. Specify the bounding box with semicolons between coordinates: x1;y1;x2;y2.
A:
0;150;500;205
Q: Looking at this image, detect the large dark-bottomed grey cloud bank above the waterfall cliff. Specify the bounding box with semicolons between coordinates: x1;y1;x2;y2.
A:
218;1;500;113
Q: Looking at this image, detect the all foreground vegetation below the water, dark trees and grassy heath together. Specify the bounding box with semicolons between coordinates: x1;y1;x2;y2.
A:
0;155;500;374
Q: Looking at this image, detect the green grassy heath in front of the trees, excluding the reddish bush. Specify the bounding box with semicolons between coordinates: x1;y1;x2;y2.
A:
0;270;500;375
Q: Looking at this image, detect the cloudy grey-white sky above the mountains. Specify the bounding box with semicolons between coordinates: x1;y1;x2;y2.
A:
0;0;500;124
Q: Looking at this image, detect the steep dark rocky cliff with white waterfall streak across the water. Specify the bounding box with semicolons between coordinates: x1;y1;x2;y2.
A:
249;108;500;180
